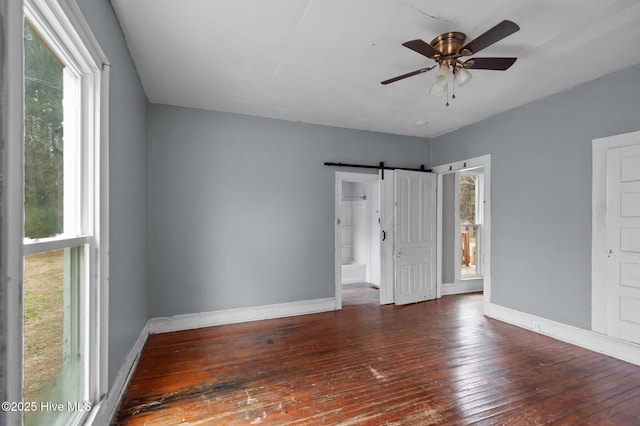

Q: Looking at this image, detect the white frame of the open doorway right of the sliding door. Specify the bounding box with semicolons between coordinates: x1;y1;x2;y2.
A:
432;154;491;315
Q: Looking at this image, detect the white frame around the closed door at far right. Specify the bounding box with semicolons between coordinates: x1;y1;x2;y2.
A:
591;131;640;334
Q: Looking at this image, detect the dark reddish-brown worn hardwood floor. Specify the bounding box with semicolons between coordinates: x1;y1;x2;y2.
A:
114;285;640;425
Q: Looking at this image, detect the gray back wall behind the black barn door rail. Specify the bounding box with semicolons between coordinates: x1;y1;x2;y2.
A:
149;105;429;317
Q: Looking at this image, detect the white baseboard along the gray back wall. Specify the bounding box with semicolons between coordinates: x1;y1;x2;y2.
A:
149;297;336;334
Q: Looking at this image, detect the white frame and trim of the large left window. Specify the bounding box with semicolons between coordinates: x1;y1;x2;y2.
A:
20;0;110;423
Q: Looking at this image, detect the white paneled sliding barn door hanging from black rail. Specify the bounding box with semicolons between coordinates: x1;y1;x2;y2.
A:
392;170;437;305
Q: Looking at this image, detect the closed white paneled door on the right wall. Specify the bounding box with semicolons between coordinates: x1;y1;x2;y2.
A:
606;141;640;343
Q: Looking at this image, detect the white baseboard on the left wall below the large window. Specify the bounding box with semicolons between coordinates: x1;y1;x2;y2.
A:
89;322;149;425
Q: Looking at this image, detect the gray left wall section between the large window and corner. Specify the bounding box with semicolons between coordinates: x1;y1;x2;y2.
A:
78;0;149;386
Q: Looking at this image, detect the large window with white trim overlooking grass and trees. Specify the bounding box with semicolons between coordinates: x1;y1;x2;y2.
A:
23;0;108;425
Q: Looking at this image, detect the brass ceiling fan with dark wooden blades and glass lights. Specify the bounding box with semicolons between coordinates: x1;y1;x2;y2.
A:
381;20;520;93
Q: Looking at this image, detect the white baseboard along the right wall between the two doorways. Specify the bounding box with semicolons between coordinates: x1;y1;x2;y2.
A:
486;303;640;365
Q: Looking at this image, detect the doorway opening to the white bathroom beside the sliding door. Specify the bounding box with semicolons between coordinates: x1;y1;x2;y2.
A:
336;172;380;309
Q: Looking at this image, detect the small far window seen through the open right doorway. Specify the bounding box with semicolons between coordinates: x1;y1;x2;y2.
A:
458;172;482;278
